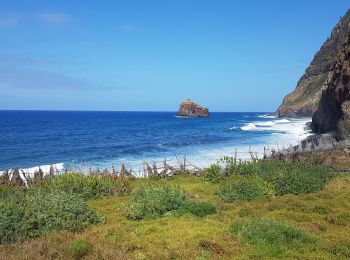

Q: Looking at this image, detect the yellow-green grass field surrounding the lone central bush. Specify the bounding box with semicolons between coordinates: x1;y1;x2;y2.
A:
0;161;350;259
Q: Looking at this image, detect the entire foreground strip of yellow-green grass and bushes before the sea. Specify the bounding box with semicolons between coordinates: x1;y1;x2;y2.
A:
0;158;350;259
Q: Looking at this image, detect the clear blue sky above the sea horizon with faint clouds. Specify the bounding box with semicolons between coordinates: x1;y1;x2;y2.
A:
0;0;350;111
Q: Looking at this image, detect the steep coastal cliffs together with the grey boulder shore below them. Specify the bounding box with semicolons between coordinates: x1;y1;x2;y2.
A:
276;10;350;161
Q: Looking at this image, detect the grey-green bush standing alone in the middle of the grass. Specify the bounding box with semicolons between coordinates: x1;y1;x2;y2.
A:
125;185;216;220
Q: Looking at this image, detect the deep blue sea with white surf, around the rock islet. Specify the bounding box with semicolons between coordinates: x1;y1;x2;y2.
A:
0;111;307;170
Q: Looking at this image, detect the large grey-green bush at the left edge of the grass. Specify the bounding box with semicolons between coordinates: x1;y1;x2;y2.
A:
0;189;102;243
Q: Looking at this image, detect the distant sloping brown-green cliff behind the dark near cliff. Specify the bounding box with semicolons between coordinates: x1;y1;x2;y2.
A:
276;10;350;117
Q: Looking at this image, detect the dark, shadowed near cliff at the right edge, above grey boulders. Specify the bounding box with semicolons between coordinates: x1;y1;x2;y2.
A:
311;33;350;139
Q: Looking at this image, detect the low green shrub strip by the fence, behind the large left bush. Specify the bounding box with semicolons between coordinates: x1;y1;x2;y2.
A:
44;173;130;199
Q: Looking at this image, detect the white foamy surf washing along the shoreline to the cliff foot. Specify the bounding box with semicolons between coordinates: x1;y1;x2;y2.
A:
0;115;311;178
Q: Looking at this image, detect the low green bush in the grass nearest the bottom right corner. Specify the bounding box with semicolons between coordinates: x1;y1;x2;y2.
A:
230;219;315;256
